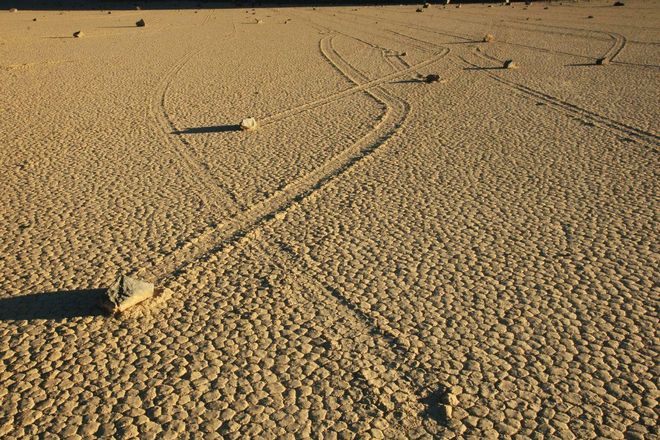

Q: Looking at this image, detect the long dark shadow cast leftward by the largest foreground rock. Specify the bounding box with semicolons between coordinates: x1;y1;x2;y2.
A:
0;289;108;321
